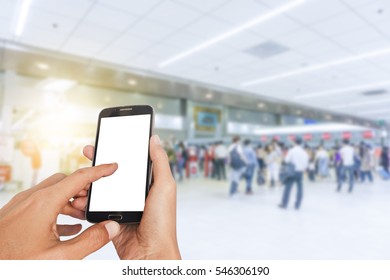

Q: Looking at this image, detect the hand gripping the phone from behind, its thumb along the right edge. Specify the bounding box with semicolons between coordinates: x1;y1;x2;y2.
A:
72;135;181;259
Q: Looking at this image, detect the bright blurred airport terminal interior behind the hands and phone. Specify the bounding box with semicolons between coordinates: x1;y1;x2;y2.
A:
0;0;390;260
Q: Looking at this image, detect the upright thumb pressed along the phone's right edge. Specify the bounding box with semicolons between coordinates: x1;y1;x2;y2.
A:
150;135;174;185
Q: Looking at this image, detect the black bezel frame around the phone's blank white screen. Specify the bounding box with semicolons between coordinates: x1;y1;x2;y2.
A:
85;105;154;224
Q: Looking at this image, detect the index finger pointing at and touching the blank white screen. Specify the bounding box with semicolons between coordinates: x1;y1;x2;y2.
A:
50;163;118;207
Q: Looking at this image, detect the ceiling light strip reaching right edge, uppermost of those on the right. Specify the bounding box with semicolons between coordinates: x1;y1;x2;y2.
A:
241;48;390;87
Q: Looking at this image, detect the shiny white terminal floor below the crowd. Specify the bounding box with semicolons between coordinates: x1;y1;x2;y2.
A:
0;176;390;259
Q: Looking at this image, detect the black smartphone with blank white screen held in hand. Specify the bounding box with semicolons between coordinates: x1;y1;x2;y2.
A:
86;105;154;223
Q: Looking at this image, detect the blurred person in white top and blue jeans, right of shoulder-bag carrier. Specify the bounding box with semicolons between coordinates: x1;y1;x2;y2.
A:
337;139;355;193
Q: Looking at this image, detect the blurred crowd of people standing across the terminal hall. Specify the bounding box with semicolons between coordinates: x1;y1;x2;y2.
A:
164;136;390;208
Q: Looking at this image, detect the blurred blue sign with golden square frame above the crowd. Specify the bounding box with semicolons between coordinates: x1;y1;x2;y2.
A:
194;106;221;132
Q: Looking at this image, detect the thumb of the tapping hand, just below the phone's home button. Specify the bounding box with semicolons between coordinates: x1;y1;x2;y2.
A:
63;221;120;259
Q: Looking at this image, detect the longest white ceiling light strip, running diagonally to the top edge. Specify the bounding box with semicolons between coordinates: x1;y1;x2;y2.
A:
158;0;306;68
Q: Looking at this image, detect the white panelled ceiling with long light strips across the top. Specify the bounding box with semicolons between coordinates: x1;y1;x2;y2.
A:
0;0;390;120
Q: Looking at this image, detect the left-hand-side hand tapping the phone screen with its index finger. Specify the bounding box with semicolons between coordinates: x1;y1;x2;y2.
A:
0;164;119;259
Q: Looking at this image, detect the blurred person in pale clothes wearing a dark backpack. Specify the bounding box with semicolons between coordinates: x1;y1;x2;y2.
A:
228;136;247;197
